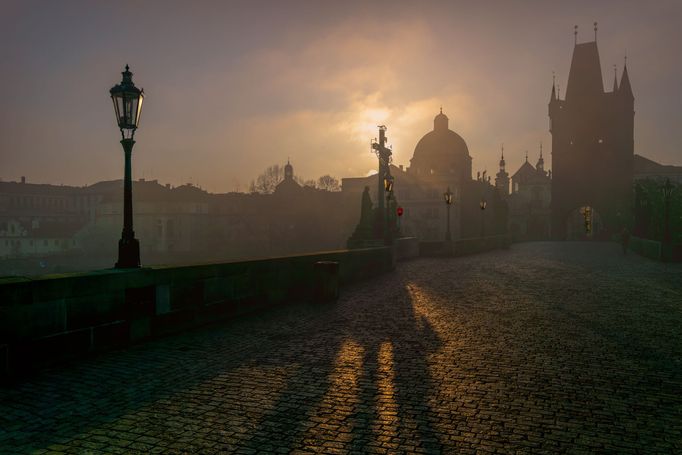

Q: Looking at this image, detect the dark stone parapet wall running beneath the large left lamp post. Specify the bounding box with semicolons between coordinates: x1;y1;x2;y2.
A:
0;247;395;376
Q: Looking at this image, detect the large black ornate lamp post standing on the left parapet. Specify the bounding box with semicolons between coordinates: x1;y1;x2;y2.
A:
109;65;144;269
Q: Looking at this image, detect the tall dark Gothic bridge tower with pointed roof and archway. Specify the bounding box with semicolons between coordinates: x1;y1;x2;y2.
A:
549;36;634;240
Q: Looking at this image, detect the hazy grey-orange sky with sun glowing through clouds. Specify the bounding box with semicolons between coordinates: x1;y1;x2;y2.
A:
0;0;682;192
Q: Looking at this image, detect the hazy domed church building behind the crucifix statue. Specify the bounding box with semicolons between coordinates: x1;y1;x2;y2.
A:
342;109;507;242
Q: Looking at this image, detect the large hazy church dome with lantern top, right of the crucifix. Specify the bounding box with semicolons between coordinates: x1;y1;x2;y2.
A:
410;110;471;179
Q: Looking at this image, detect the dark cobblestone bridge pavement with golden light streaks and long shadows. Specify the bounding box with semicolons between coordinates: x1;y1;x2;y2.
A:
0;243;682;454
